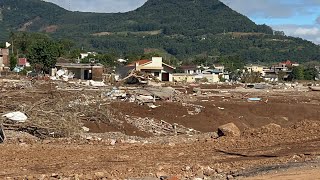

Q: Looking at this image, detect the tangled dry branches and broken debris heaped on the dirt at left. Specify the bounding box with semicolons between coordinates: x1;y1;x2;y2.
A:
0;81;196;139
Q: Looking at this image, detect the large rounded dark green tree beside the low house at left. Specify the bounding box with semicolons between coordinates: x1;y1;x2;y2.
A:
27;39;60;73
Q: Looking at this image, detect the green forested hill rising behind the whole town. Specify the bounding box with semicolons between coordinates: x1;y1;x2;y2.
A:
0;0;319;62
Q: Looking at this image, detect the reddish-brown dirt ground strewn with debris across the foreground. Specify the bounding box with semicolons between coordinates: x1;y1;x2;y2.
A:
0;81;320;179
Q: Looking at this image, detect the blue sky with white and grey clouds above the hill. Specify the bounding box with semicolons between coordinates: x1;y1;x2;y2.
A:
46;0;320;44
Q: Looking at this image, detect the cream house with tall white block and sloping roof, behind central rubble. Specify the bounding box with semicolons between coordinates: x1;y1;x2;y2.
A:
127;57;176;82
